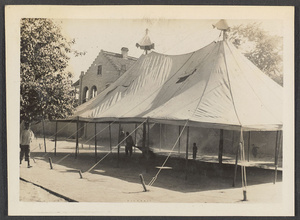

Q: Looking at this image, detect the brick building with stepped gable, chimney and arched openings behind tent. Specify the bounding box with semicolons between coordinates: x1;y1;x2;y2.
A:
73;47;137;105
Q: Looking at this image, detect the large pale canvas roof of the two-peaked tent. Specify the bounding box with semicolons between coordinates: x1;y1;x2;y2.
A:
72;41;282;130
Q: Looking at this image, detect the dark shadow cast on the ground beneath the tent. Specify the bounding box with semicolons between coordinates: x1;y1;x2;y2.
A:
31;149;282;192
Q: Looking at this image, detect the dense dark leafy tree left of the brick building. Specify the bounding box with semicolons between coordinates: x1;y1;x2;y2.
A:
20;18;75;122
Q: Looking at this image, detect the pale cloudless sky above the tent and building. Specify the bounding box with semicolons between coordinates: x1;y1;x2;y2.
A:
56;19;283;82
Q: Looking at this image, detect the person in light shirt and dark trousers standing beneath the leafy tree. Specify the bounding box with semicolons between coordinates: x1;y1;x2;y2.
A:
20;122;34;168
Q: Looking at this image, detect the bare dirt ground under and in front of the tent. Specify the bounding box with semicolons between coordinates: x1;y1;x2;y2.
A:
20;139;282;203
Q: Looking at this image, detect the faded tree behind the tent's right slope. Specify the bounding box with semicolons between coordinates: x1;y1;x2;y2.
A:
229;23;283;85
